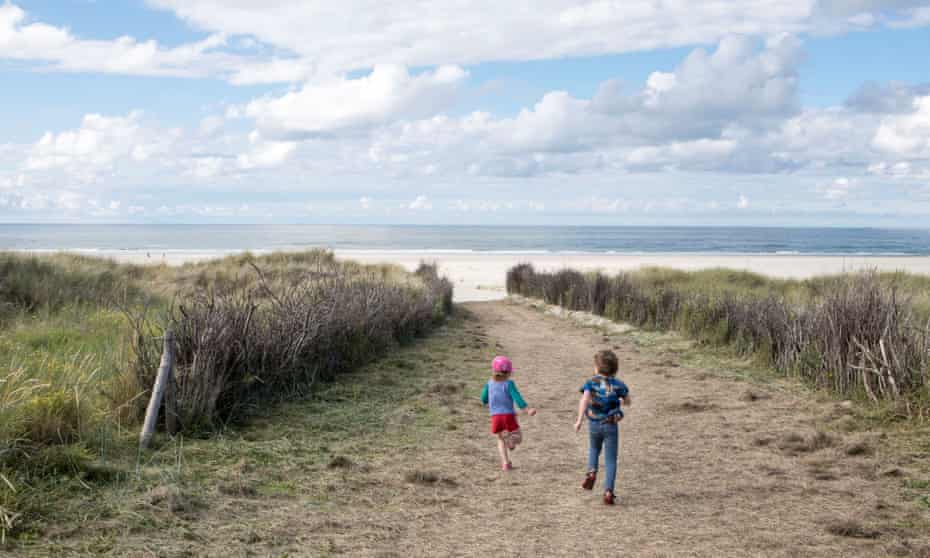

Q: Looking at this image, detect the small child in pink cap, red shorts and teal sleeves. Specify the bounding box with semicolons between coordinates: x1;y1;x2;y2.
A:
481;356;536;471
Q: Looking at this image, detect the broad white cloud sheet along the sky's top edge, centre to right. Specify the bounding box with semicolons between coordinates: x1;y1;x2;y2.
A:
150;0;923;73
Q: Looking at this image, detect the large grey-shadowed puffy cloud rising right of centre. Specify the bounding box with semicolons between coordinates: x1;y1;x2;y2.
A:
368;36;800;177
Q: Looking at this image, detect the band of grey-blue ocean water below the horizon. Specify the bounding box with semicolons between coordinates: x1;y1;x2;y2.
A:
0;224;930;256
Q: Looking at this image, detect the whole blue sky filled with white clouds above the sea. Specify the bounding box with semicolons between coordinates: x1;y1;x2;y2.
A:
0;0;930;227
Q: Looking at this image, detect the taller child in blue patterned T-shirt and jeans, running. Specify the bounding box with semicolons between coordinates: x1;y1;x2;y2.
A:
575;351;633;506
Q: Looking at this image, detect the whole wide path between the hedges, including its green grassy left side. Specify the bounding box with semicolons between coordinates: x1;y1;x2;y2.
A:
14;302;930;557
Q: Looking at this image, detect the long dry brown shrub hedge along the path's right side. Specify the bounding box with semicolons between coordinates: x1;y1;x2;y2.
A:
507;264;930;416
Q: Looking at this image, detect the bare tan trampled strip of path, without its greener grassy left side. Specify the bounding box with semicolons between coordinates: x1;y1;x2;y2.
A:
391;303;923;556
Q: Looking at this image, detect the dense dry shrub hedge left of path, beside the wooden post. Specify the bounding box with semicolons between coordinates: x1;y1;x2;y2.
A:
135;253;452;431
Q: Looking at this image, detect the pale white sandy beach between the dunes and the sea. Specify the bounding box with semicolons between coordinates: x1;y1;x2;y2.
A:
34;250;930;302
